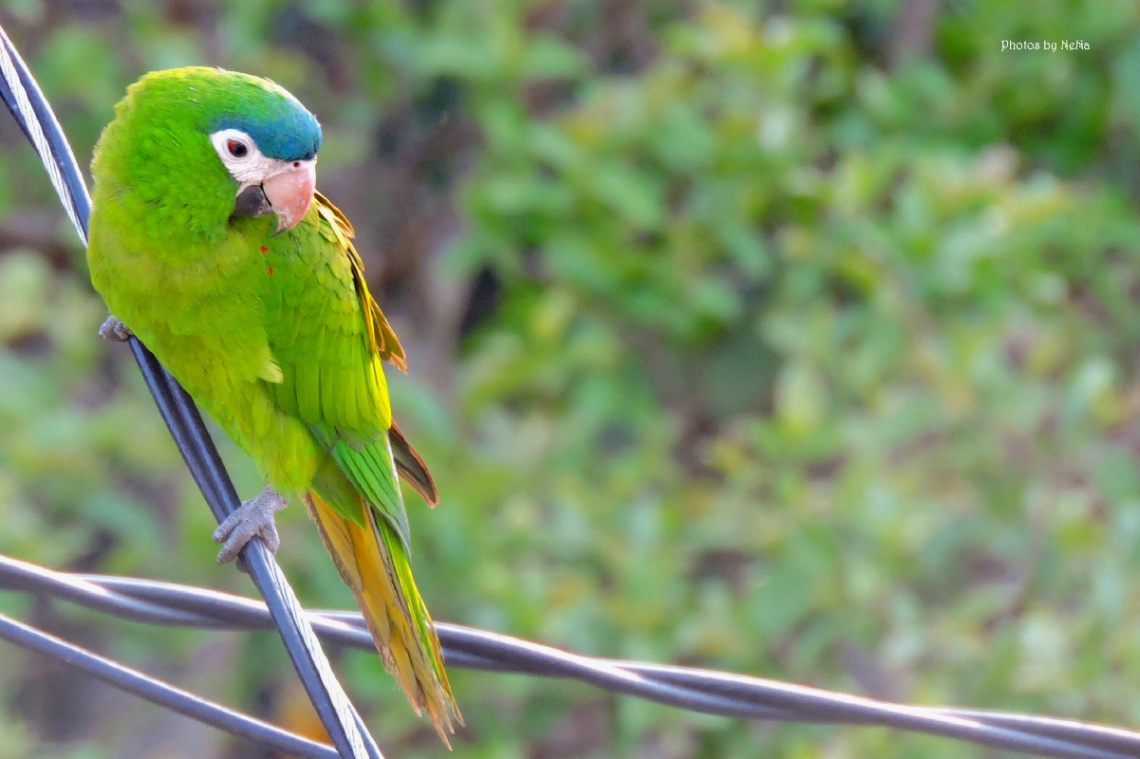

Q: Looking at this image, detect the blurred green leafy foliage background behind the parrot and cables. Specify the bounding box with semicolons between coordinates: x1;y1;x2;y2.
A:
0;0;1140;759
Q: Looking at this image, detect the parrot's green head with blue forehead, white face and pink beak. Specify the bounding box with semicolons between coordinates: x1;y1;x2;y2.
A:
92;67;321;238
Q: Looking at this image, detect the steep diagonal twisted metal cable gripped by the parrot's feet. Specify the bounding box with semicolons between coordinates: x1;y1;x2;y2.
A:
0;20;383;759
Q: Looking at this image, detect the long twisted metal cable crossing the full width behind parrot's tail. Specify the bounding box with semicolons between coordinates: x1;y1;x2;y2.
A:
0;555;1140;759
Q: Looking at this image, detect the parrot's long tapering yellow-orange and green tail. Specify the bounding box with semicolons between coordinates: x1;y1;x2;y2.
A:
302;491;463;748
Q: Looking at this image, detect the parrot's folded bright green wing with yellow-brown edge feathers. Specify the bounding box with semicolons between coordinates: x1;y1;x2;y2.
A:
266;195;408;528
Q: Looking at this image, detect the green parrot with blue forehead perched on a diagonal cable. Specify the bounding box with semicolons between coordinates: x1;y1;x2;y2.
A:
88;67;463;743
